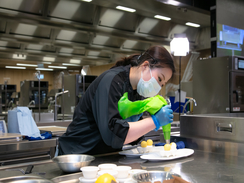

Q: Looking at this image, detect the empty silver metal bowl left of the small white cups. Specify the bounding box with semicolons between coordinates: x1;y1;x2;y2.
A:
53;154;95;173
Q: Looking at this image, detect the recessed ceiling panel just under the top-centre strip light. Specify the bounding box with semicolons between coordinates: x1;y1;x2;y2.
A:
99;8;138;31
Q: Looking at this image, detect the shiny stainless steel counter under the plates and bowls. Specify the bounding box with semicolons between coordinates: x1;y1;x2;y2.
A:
0;147;244;183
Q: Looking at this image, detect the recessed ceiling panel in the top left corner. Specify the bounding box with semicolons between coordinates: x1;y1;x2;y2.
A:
0;0;44;14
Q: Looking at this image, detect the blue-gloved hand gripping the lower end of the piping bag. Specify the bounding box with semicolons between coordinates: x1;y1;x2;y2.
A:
152;105;174;130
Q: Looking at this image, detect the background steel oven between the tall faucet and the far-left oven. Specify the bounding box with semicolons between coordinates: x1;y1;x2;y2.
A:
19;80;48;109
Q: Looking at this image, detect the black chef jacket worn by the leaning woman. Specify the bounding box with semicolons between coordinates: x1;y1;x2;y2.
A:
59;65;143;155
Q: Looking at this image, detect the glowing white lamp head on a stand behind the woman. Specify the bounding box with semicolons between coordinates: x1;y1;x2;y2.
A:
170;34;189;56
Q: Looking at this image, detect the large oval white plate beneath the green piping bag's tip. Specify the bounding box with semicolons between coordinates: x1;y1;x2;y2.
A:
140;148;194;161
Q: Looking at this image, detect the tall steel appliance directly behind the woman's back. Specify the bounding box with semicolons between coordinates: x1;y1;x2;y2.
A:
62;74;97;114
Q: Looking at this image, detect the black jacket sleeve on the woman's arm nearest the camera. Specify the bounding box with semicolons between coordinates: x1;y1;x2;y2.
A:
92;71;129;149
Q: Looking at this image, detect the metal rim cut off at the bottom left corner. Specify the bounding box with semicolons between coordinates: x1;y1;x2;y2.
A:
0;176;53;183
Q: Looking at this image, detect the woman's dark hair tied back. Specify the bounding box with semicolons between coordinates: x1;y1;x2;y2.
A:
112;46;175;73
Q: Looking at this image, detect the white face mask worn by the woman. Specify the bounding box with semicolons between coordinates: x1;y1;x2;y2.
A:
137;69;161;97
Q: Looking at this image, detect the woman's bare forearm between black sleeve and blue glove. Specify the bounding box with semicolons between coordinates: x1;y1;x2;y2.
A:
124;117;155;144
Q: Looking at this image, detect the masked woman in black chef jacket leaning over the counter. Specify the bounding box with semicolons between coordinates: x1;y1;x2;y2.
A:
59;46;175;155
